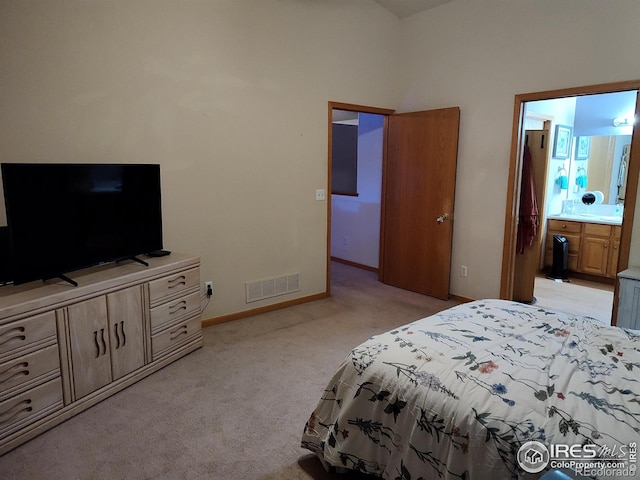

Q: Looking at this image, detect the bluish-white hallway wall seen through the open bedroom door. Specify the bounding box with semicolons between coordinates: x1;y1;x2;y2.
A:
331;113;384;268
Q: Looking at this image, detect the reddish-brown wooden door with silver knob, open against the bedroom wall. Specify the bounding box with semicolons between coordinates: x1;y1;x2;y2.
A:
380;107;460;299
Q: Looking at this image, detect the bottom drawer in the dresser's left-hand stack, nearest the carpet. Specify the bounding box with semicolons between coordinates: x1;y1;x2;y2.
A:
0;378;62;438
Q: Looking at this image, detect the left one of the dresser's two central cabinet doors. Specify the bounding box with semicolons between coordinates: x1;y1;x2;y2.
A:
67;296;111;400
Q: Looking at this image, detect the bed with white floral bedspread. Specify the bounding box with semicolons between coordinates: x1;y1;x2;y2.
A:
301;299;640;480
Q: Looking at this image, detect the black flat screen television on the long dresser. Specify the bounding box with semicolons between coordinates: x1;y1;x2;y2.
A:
0;163;162;284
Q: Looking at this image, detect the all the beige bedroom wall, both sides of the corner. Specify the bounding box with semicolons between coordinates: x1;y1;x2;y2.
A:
0;0;640;318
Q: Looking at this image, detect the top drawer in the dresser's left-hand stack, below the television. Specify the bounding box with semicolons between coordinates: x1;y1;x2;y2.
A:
0;311;56;359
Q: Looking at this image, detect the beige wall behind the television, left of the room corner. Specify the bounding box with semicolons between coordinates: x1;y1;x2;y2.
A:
0;0;400;319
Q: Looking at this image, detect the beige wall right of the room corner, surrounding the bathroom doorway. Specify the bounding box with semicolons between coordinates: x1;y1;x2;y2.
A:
400;0;640;298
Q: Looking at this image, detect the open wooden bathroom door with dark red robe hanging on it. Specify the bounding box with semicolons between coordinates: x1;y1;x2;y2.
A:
513;130;549;303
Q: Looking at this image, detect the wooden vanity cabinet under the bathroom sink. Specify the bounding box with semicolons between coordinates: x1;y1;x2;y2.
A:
544;219;621;278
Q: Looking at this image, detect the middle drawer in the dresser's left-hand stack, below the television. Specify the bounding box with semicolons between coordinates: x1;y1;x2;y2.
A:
0;345;60;400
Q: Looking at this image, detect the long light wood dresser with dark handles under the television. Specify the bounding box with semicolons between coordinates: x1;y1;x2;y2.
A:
0;253;202;454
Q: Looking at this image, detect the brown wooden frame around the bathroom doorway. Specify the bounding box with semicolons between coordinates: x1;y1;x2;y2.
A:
500;81;640;325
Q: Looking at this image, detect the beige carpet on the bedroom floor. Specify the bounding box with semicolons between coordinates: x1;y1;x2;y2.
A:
0;263;456;480
